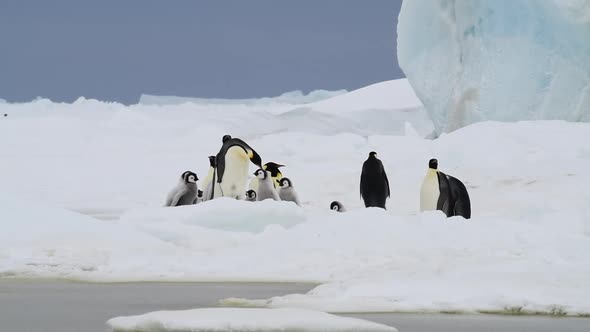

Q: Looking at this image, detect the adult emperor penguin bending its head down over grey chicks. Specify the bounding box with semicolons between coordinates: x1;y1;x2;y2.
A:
209;135;262;199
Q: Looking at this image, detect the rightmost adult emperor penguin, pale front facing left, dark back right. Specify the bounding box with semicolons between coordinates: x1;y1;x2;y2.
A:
420;159;471;219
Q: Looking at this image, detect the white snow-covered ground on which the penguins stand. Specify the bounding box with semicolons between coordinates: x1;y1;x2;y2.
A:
0;80;590;314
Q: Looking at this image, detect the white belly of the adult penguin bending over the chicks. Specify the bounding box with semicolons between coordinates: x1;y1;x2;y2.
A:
221;146;250;199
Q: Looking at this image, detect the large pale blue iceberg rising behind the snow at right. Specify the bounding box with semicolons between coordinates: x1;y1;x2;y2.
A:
397;0;590;133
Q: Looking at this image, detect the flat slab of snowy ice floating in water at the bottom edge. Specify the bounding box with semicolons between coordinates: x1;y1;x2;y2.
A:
107;308;397;332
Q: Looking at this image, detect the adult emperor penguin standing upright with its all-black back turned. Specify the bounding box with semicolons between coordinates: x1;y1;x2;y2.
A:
361;151;390;209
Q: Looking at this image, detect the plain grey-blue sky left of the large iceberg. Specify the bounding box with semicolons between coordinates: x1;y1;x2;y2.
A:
0;0;403;103
